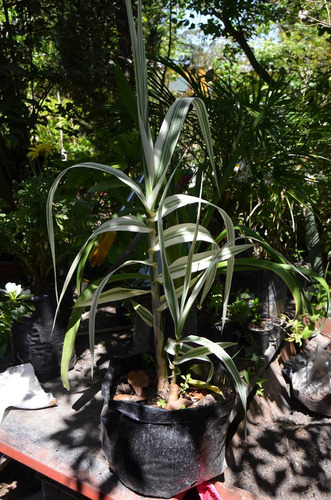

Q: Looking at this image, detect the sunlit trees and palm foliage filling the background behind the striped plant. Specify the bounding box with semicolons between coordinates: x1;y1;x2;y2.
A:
0;0;331;304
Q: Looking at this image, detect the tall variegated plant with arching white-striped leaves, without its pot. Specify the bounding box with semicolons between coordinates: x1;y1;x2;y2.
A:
47;0;251;412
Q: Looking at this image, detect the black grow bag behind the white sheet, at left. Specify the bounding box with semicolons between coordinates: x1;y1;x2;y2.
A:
12;294;75;382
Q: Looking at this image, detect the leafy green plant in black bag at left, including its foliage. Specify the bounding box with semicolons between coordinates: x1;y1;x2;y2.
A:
0;158;102;380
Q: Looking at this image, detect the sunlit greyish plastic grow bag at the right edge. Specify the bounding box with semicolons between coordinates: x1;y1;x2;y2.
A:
283;347;331;417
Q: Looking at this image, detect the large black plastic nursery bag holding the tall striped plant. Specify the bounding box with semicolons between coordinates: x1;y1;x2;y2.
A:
101;358;234;498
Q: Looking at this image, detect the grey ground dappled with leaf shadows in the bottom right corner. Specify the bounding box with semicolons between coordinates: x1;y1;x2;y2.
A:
225;412;331;500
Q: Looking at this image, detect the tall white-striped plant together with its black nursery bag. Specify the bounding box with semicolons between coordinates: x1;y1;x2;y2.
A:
47;0;328;498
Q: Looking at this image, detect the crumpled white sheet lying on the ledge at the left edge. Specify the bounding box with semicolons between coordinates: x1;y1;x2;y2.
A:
0;363;56;423
